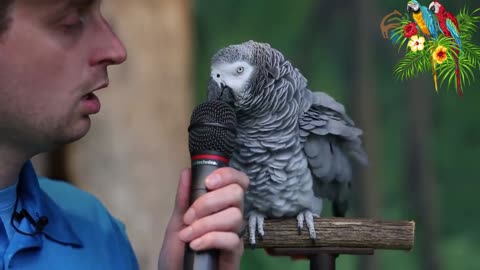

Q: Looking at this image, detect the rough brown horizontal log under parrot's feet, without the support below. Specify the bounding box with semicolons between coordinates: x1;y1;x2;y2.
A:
244;218;415;253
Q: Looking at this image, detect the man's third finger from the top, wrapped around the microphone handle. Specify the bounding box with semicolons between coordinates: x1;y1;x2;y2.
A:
179;207;244;242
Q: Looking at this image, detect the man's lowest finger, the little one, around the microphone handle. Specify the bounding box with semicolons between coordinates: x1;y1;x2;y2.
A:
190;232;243;253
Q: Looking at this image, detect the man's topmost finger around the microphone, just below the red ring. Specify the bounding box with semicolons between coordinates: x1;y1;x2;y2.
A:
205;167;249;190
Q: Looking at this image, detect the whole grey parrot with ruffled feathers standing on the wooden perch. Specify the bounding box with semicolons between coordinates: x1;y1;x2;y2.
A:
208;41;368;245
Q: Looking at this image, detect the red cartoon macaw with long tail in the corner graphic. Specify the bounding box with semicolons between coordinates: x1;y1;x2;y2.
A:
429;1;463;96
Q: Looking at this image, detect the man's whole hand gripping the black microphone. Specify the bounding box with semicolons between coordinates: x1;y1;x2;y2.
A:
158;167;249;270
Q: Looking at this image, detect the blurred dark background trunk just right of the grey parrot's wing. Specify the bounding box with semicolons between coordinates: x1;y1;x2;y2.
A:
350;0;380;270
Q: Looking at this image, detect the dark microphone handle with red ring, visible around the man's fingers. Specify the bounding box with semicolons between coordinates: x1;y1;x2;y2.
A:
183;151;228;270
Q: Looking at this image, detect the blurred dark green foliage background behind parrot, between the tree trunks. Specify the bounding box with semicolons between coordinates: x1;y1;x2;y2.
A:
194;0;480;270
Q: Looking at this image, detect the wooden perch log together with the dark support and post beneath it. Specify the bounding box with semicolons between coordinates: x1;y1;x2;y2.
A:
244;218;415;270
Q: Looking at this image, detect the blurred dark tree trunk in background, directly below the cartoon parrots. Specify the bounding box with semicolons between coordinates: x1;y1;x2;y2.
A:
406;79;440;270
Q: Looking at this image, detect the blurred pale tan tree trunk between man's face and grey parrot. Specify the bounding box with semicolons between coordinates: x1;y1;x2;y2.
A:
66;0;193;269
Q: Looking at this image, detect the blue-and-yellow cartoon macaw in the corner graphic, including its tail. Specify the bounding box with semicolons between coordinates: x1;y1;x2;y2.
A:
407;0;438;92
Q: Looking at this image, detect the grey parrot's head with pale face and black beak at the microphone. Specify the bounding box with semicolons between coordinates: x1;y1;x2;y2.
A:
208;41;283;108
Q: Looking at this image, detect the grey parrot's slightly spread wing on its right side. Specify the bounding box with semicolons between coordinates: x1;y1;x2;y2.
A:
299;91;368;207
